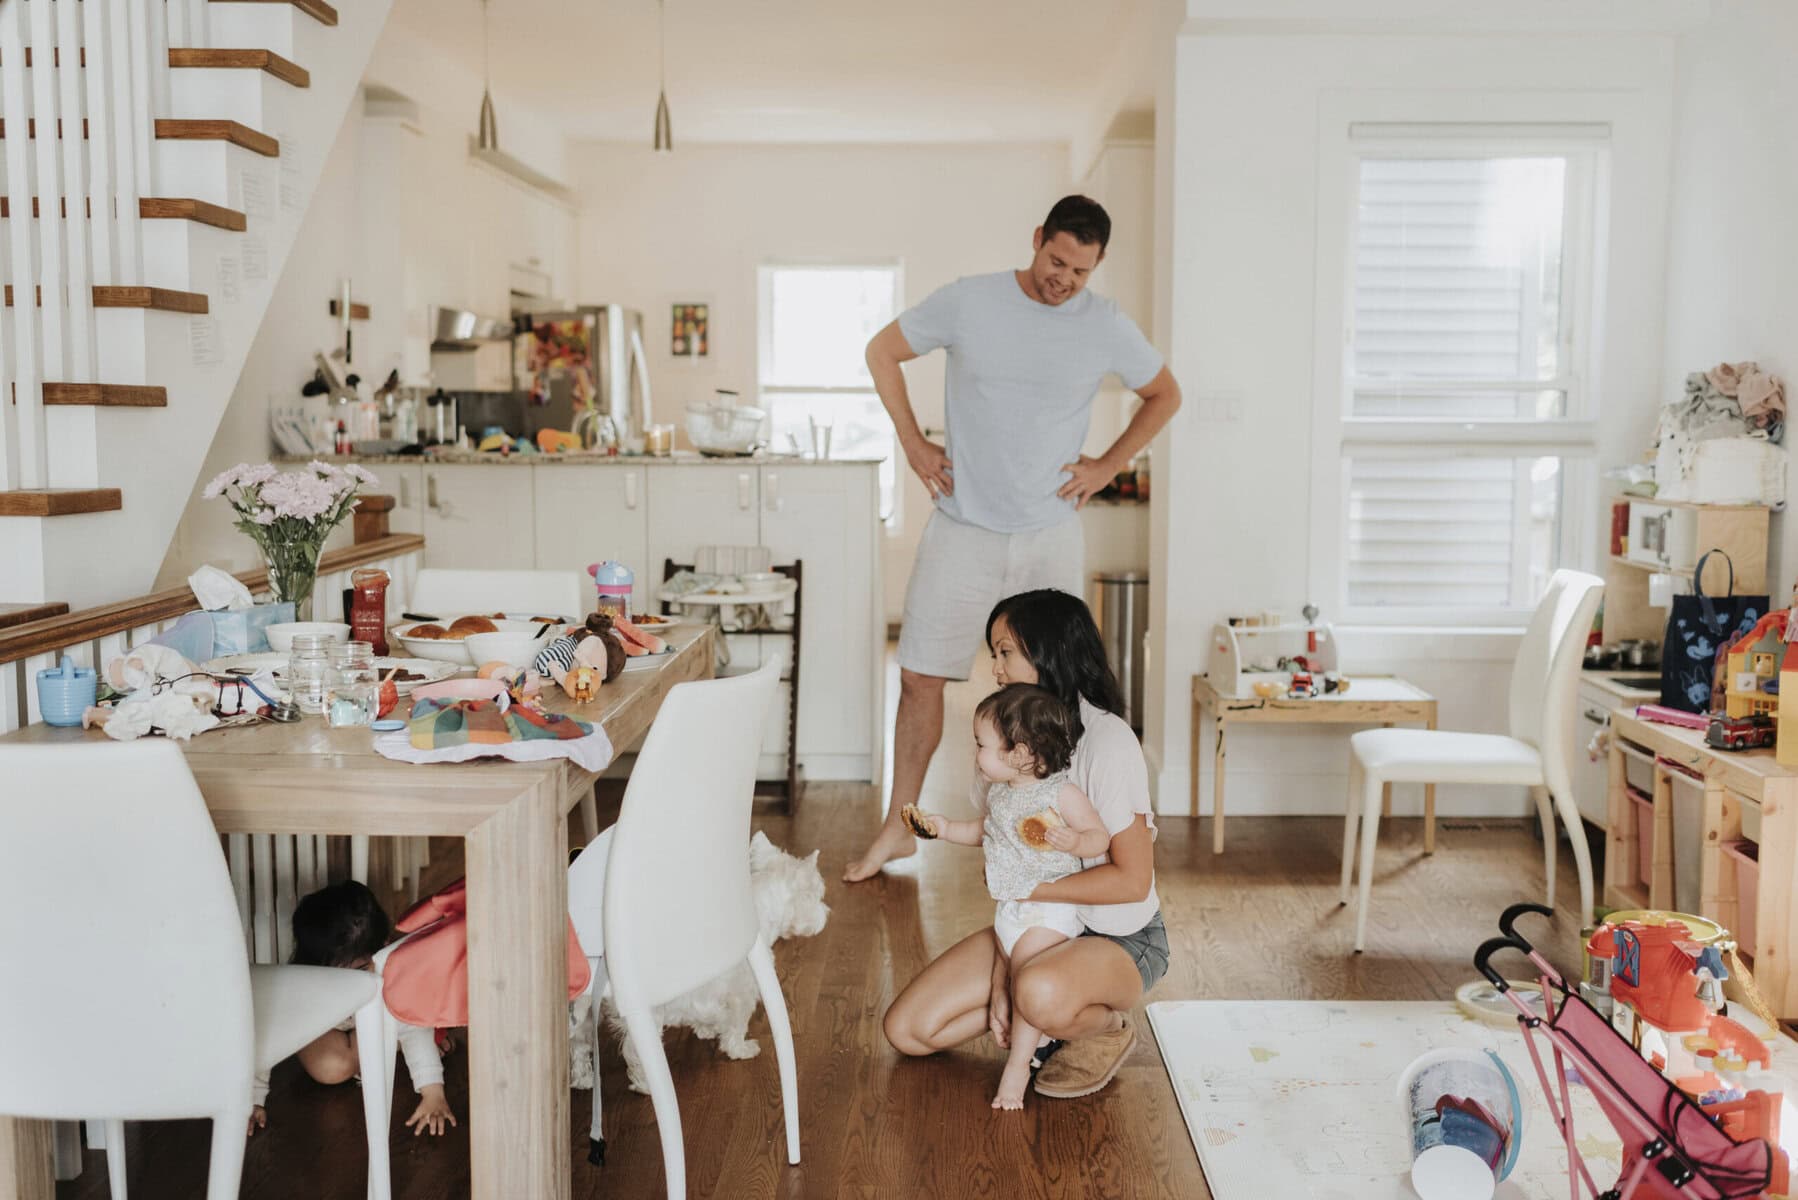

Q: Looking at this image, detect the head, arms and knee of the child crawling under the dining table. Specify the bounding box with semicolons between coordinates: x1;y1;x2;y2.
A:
248;880;455;1135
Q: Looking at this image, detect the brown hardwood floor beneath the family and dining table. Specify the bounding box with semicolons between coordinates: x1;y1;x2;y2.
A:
58;788;1577;1200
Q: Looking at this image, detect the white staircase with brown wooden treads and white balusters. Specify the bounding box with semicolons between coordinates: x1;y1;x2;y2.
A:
0;0;392;608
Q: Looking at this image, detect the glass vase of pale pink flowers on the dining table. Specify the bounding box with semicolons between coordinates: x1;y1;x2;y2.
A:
201;462;378;621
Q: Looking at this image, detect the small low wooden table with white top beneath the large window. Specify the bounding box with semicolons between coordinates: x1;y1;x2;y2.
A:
1192;675;1437;855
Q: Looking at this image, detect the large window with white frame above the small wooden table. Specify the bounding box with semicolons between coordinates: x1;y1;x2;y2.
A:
1316;126;1604;624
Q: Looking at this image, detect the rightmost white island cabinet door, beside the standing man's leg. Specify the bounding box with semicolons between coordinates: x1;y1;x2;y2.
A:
761;466;885;779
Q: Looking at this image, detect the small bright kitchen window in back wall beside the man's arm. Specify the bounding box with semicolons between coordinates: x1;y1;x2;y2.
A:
759;263;901;533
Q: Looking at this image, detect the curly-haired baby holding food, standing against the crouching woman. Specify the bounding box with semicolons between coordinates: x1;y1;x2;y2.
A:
901;684;1111;1108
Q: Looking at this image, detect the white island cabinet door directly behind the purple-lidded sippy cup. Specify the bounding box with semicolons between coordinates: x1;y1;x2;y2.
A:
528;466;662;612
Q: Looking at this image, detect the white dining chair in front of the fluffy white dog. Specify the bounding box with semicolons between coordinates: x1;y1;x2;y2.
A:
568;657;800;1200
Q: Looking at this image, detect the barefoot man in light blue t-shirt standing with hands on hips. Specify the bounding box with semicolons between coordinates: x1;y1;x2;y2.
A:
843;196;1179;883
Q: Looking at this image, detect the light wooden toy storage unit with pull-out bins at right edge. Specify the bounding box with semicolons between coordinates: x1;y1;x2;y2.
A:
1604;709;1798;1018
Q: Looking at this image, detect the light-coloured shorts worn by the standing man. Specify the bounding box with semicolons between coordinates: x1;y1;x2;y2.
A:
899;513;1086;680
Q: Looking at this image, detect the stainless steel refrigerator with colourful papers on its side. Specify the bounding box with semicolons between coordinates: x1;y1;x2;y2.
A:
512;304;651;443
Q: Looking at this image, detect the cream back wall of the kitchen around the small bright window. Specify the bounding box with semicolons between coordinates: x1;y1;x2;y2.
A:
570;142;1064;621
